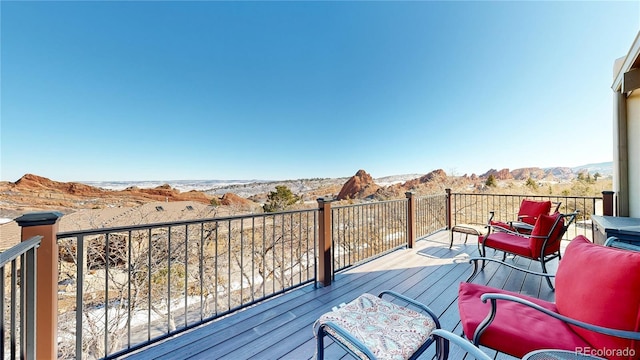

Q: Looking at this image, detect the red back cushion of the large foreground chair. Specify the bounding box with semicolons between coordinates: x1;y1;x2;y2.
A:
556;235;640;359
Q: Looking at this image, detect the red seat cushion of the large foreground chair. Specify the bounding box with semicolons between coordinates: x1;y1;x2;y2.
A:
458;284;588;358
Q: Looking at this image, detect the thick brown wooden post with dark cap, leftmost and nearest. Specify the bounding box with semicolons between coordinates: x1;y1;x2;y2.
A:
16;212;62;359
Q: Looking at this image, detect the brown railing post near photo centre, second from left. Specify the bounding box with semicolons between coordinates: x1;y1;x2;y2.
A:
317;198;333;286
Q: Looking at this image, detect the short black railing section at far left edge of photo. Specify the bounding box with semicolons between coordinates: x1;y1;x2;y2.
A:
0;236;42;359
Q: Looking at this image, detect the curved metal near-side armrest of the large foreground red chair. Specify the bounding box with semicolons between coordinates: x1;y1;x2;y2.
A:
473;293;640;345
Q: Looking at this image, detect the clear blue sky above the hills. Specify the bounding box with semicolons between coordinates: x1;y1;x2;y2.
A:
0;1;640;181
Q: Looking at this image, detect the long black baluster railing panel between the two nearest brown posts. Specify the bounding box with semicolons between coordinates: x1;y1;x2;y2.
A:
57;210;317;359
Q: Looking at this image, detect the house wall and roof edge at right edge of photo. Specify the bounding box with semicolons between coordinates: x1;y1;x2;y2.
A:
611;32;640;218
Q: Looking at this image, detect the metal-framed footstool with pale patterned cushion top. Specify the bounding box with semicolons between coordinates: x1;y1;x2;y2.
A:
313;291;449;360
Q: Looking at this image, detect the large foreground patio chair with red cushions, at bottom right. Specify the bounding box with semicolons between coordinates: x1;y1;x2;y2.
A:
458;235;640;360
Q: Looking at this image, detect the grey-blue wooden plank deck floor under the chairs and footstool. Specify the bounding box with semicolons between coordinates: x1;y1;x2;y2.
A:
121;231;557;360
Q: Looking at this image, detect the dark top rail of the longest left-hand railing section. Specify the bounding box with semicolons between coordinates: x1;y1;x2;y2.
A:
57;205;318;239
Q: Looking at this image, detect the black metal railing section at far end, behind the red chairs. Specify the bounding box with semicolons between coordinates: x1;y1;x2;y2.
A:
451;193;602;239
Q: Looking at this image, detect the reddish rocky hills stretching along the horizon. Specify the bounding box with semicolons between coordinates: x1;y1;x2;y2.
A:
0;162;612;218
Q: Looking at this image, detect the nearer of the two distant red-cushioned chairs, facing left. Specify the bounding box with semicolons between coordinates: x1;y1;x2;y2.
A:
478;212;578;289
